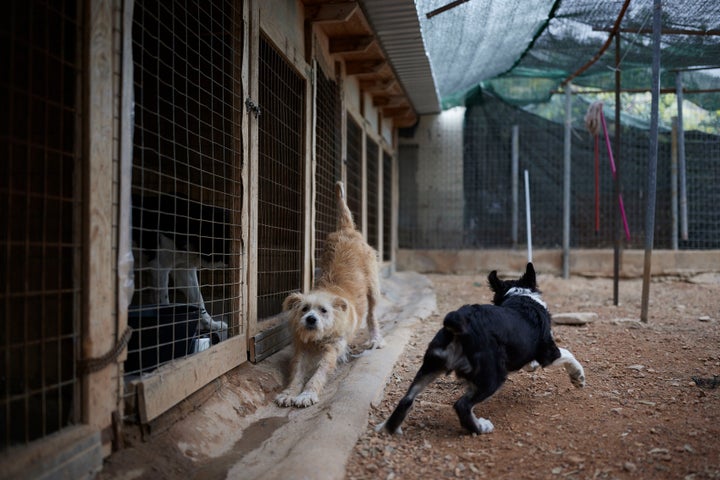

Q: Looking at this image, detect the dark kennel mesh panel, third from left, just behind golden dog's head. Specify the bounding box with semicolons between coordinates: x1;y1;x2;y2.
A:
257;37;305;319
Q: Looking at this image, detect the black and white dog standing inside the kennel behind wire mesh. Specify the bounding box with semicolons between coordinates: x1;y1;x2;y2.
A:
132;194;231;332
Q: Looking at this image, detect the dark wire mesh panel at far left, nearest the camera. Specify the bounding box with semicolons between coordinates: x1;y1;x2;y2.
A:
0;1;83;452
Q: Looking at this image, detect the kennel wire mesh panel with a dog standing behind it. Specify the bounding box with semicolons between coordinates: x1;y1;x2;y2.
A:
125;0;244;375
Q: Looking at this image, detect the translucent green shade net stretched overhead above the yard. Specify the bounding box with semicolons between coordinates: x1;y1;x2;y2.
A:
416;0;720;111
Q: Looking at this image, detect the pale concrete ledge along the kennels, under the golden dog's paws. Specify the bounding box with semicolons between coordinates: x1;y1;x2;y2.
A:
96;272;437;480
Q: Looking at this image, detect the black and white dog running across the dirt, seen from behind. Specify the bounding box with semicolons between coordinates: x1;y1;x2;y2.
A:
376;263;585;434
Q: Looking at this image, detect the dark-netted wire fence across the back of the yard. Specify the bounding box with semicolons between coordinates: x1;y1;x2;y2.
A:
399;96;720;249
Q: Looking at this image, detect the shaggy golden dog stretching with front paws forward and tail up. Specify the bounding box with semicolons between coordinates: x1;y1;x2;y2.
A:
275;182;384;407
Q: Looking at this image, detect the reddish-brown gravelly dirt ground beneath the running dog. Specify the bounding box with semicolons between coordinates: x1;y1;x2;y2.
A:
346;275;720;480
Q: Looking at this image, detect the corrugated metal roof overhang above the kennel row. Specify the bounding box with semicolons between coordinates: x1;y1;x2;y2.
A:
360;0;440;115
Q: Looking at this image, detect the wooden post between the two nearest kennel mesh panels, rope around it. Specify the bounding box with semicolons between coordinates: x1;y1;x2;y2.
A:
82;0;121;455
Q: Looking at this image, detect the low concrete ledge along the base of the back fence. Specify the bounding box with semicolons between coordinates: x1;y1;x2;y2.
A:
397;249;720;278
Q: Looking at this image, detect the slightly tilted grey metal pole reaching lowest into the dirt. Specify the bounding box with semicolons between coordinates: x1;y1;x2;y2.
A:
640;0;662;322
